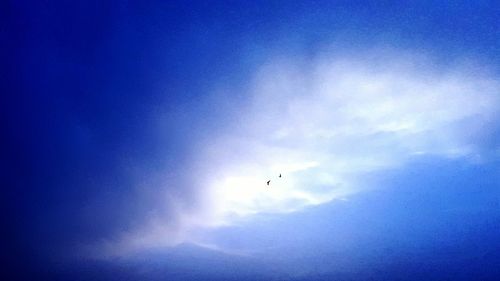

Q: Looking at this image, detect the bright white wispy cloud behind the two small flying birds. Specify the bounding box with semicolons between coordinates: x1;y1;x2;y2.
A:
94;48;500;254
